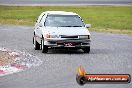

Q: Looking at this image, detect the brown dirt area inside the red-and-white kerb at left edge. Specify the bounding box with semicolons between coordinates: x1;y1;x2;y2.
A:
0;50;15;66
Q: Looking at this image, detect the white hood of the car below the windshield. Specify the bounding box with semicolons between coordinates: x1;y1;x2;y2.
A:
43;27;90;35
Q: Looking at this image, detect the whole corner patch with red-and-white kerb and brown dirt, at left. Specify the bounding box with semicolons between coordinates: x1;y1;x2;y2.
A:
0;48;42;76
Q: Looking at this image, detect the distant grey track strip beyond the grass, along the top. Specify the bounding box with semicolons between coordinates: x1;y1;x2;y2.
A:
0;0;132;6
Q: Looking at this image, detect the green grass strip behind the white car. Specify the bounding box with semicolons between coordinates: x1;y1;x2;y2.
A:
0;6;132;33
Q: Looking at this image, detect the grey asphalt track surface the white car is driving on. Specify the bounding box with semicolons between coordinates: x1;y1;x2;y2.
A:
0;25;132;88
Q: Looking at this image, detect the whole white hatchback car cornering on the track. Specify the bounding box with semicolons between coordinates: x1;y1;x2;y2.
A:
33;11;91;53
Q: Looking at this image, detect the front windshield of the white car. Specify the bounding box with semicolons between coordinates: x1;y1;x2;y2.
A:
45;15;84;27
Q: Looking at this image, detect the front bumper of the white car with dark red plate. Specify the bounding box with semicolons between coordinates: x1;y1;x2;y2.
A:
44;38;91;48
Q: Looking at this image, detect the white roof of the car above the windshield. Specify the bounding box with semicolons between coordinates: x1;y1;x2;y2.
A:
45;11;77;15
